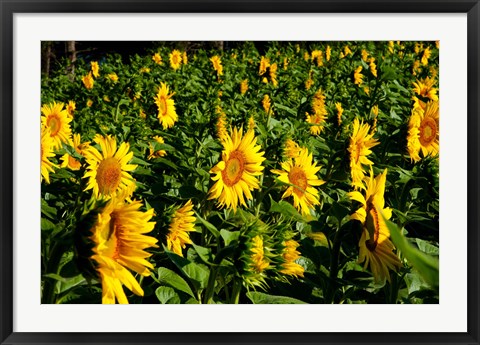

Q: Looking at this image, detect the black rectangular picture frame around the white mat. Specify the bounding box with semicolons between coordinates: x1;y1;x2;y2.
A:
0;0;480;345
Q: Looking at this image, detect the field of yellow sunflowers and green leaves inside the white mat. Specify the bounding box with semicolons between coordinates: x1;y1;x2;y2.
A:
39;41;439;304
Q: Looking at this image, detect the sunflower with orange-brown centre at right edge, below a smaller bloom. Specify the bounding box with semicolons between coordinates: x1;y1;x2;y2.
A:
407;101;440;162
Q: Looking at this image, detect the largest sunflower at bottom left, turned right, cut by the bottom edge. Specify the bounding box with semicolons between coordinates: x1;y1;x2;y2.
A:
91;198;157;304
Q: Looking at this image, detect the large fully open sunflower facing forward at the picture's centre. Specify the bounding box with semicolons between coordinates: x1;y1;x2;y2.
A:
209;128;265;211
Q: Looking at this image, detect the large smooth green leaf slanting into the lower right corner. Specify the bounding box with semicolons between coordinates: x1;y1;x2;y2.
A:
385;219;439;288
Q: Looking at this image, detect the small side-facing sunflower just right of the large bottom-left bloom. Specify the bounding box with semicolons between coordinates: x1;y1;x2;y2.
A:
167;200;197;256
